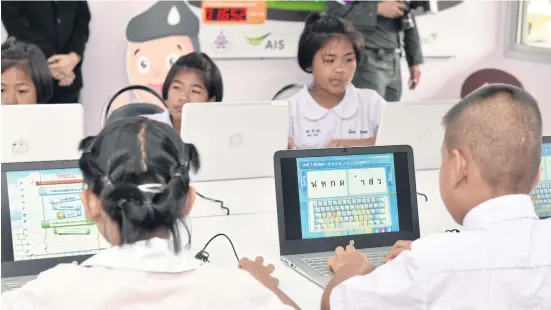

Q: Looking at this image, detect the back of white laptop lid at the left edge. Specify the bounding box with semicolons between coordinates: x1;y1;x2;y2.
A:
0;104;84;163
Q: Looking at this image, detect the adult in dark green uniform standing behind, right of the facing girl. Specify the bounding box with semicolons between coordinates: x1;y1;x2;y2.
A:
327;1;423;101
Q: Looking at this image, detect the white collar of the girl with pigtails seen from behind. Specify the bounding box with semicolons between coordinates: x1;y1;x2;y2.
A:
81;238;202;273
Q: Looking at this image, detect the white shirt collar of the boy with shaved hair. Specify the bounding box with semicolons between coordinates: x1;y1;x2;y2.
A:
463;195;538;230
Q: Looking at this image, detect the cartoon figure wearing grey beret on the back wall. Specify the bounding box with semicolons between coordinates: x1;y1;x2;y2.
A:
112;1;200;108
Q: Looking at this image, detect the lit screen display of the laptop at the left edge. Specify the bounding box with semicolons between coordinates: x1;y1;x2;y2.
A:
6;169;108;261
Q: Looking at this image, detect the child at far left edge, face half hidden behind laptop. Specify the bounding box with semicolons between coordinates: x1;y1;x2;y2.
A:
2;37;54;104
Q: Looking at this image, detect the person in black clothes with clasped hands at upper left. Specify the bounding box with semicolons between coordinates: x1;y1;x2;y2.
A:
2;1;90;103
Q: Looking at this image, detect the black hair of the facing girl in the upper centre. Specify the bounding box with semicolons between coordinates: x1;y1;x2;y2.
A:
297;12;365;73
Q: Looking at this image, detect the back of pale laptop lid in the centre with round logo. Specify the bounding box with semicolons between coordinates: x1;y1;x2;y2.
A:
181;101;289;182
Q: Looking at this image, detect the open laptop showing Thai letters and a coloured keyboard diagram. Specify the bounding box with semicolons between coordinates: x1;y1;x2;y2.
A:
274;145;420;287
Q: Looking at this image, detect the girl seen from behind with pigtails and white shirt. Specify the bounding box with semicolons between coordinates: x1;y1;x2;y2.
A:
1;118;296;310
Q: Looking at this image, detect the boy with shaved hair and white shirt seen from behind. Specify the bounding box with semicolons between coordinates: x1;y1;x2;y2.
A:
322;84;551;310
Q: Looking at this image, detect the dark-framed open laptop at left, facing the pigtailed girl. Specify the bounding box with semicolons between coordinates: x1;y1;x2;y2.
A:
1;161;109;292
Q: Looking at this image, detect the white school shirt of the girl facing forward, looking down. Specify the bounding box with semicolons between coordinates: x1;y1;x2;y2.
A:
287;83;386;149
